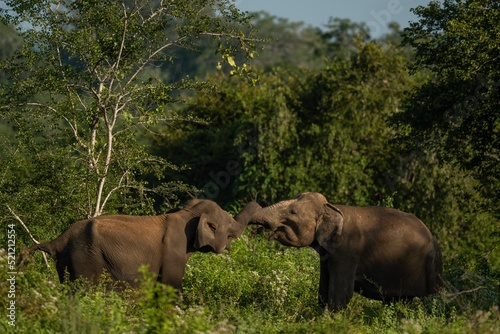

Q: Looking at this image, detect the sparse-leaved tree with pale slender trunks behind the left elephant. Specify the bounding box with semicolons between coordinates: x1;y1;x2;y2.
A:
0;0;254;222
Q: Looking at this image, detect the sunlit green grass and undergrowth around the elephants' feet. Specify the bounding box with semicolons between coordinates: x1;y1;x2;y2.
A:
0;232;500;333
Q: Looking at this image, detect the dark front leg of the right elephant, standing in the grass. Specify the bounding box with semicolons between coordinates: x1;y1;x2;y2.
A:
327;258;356;311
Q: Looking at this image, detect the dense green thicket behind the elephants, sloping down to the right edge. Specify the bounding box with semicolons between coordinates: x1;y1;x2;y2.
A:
153;32;500;268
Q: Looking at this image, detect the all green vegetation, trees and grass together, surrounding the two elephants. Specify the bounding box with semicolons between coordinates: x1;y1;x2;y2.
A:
0;0;500;333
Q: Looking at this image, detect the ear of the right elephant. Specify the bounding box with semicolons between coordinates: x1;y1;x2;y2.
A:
316;203;344;252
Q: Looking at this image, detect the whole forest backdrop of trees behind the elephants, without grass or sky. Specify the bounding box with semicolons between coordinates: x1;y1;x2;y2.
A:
0;1;500;332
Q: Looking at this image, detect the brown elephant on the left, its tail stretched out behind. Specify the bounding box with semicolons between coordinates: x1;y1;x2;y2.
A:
24;199;254;289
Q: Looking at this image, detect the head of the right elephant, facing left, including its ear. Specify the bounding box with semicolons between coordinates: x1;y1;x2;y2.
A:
250;193;344;248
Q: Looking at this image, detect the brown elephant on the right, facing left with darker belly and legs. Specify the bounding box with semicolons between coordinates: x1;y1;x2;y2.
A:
250;193;443;310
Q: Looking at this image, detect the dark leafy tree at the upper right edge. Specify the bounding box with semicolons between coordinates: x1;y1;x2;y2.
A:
393;0;500;213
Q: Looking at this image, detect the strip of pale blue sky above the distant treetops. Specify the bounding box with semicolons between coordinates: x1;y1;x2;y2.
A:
235;0;436;37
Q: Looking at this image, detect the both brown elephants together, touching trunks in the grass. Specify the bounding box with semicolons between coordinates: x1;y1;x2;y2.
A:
28;193;443;310
